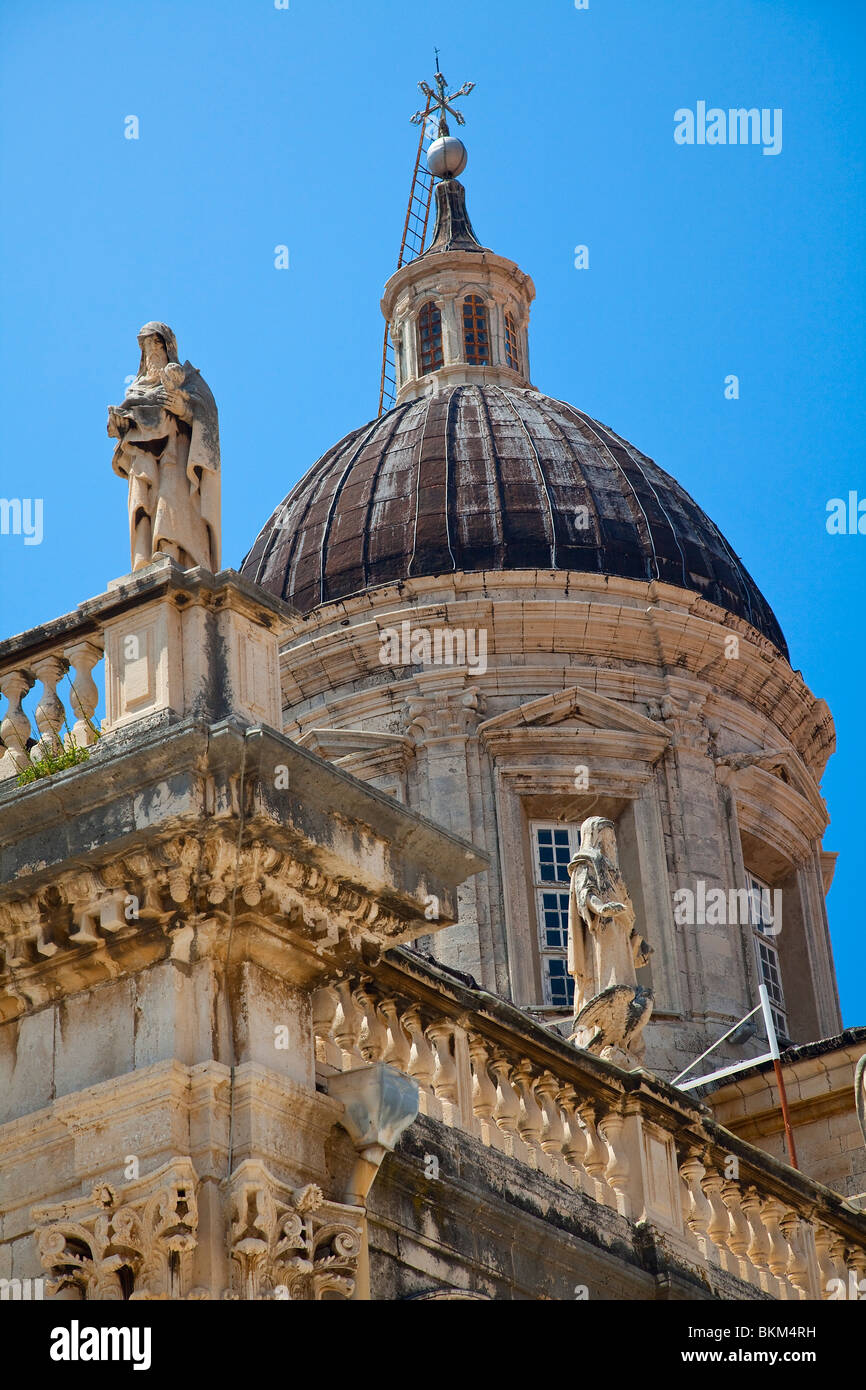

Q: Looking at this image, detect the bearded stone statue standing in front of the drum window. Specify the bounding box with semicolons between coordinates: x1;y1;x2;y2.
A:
569;816;653;1066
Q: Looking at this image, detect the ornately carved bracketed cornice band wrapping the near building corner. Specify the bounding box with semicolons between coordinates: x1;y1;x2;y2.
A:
0;826;439;1016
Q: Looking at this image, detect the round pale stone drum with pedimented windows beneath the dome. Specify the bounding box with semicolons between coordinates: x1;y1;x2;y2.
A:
281;573;840;1077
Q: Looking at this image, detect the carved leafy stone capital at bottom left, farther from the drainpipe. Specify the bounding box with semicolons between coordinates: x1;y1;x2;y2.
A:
32;1158;202;1301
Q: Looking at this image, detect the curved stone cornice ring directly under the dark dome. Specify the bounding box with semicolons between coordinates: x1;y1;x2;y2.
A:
281;570;835;776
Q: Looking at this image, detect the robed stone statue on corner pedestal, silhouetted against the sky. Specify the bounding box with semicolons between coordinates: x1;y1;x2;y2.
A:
108;324;220;573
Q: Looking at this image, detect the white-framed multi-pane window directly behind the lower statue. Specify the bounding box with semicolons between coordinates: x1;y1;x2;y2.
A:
530;820;580;1009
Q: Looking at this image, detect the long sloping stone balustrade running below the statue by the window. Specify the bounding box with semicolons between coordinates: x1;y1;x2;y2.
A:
313;949;866;1300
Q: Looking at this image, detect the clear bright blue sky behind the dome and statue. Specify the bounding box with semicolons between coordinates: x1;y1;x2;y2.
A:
0;0;866;1023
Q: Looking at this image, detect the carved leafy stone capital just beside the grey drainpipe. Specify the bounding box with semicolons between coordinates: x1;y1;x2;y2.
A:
224;1159;364;1302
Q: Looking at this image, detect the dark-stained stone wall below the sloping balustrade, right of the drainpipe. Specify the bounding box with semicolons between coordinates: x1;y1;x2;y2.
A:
370;1116;760;1302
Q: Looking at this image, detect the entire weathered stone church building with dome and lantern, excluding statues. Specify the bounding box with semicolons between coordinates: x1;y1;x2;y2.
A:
0;122;866;1302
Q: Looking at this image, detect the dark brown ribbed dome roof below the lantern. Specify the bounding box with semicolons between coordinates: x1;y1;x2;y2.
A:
240;384;788;656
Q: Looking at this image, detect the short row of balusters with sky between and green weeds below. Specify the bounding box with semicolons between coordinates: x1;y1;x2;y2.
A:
0;627;103;783
